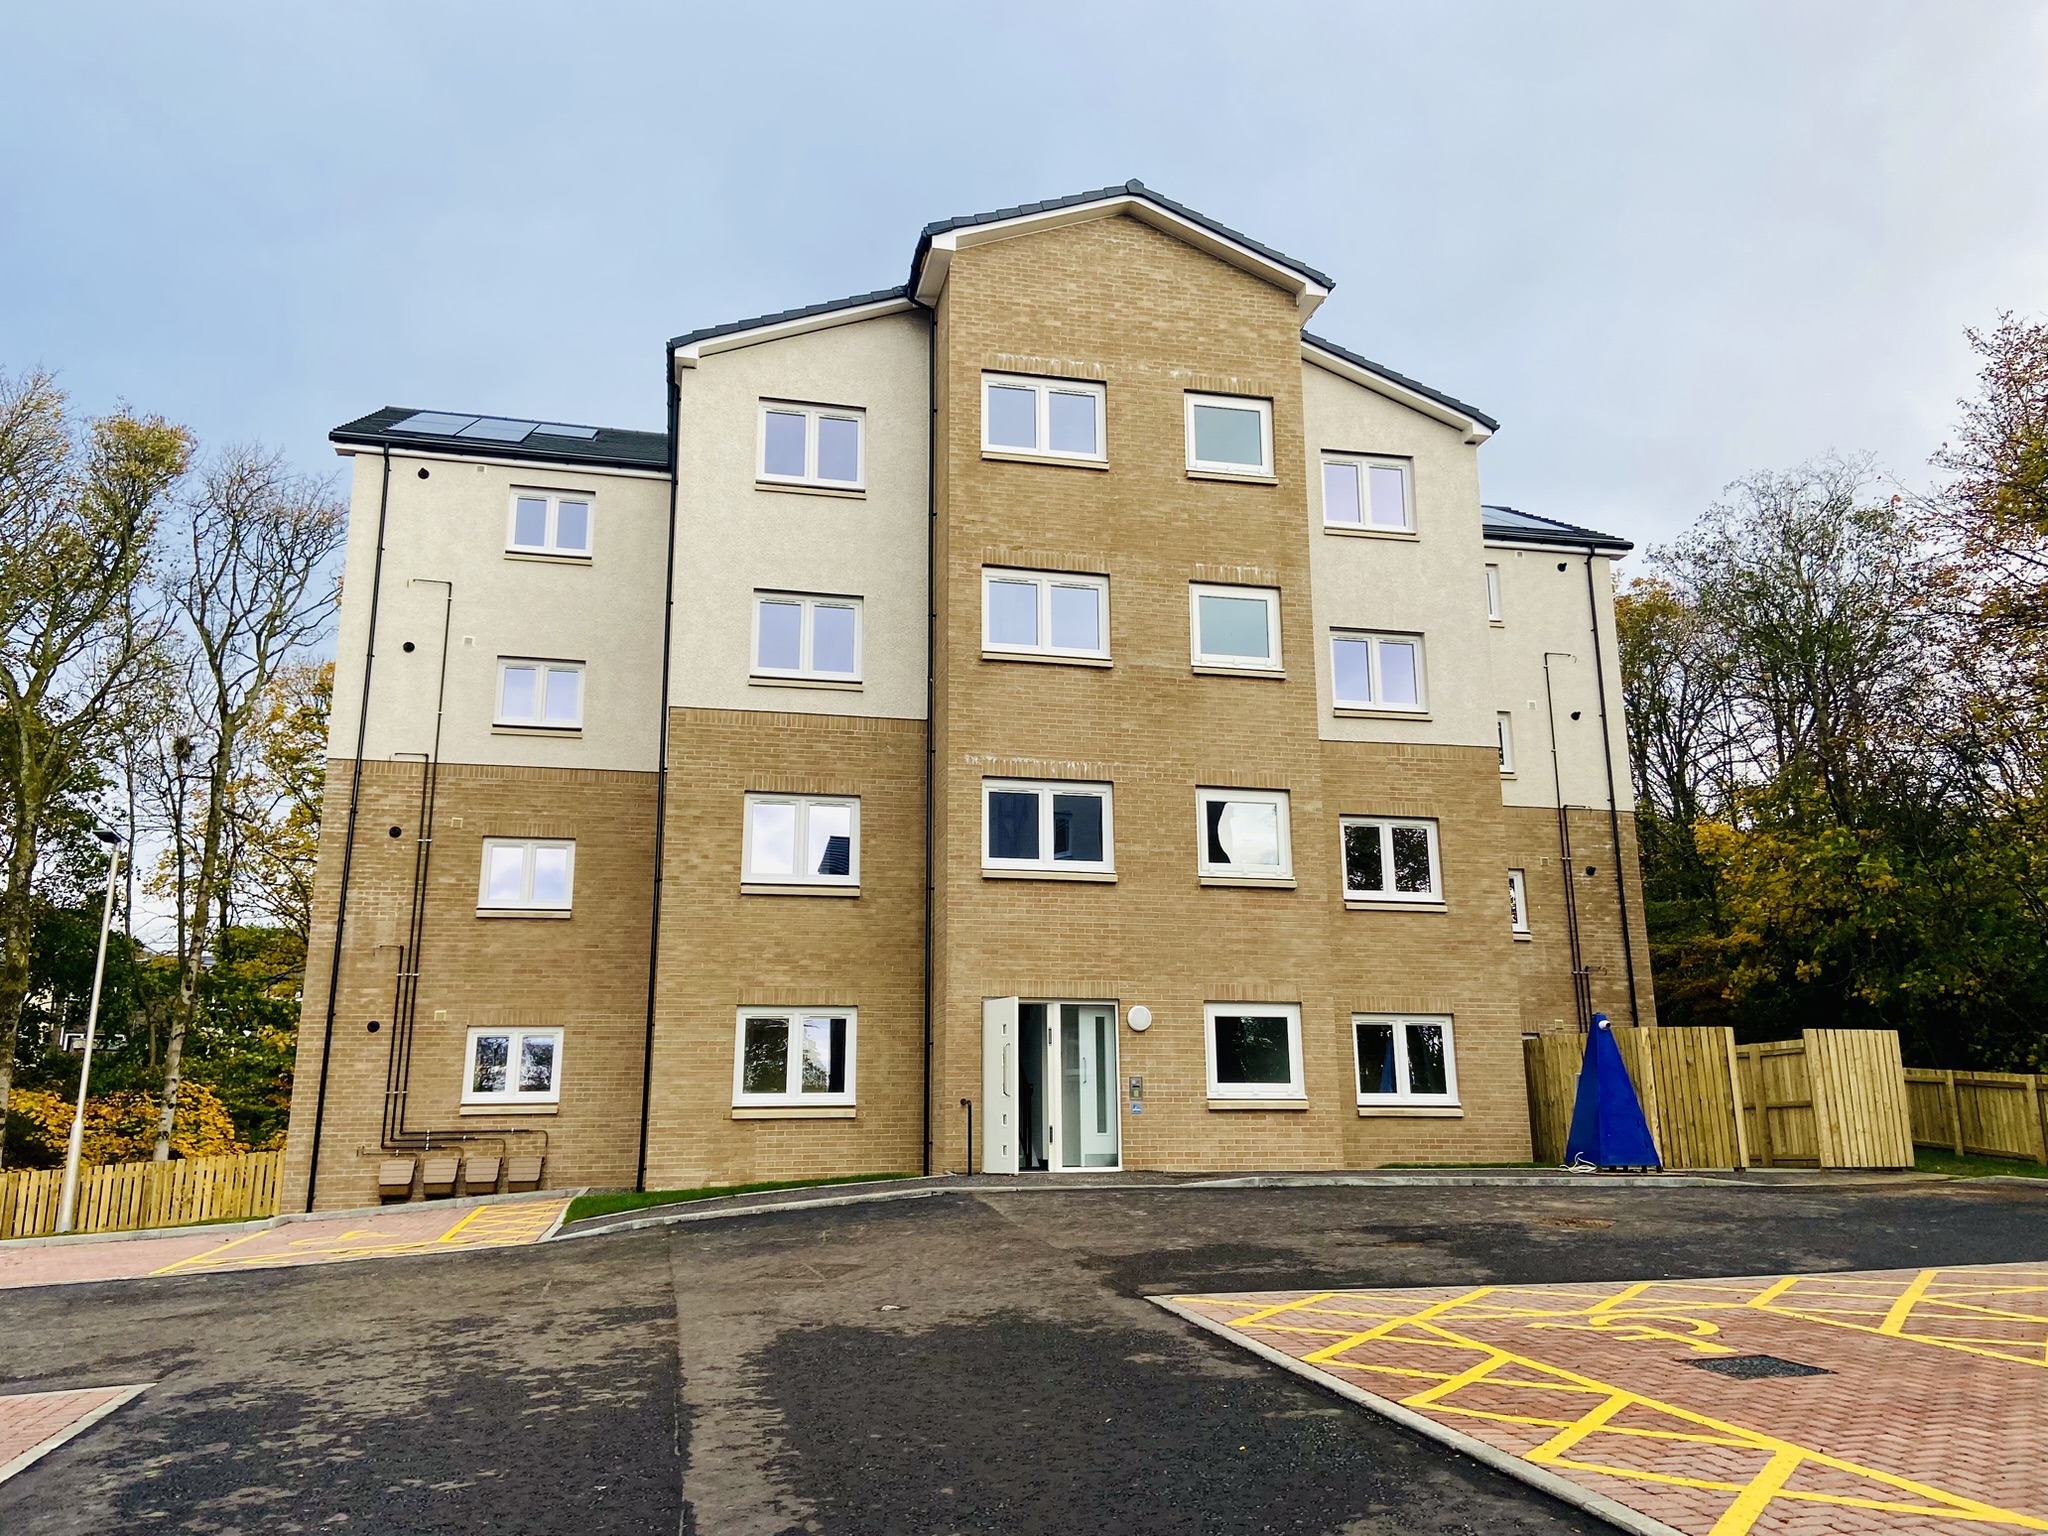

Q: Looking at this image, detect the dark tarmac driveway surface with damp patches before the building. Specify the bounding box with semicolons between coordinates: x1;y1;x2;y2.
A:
0;1178;2048;1536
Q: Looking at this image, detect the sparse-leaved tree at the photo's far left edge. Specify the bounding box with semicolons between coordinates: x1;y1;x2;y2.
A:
0;373;190;1163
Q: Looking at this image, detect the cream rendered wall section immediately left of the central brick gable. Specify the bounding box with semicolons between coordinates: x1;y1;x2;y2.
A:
670;313;932;719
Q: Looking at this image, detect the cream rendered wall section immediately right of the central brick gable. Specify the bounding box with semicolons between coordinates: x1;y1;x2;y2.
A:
1282;362;1499;748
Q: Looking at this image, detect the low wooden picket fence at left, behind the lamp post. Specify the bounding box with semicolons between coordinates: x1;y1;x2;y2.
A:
0;1151;285;1237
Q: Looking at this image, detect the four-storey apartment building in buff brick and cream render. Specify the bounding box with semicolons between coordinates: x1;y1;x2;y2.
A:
285;182;1651;1208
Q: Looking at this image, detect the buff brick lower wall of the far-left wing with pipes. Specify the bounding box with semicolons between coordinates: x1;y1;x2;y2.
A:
283;760;655;1210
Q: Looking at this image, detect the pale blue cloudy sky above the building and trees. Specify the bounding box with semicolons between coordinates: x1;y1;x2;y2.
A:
0;0;2048;561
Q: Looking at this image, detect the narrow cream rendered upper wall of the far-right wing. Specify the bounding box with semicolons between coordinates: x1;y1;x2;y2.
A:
1485;545;1634;811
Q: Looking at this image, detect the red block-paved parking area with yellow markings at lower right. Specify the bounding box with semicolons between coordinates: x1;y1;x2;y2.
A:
1155;1264;2048;1536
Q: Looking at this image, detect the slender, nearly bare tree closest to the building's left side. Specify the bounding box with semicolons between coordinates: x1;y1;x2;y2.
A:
156;449;346;1161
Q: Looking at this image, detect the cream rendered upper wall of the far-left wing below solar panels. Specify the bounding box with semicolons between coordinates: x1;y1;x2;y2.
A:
328;451;668;772
